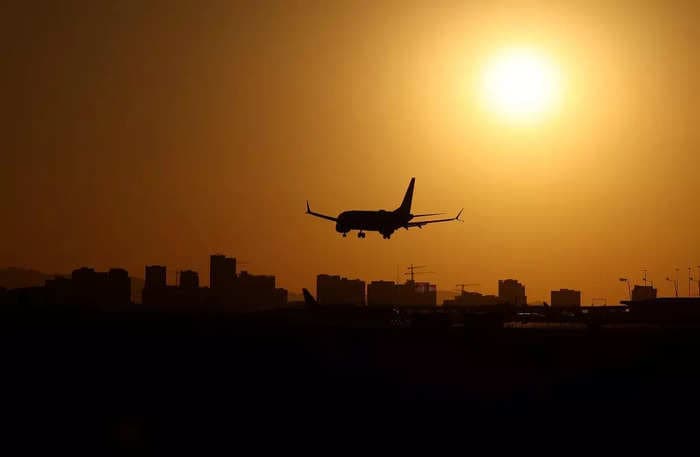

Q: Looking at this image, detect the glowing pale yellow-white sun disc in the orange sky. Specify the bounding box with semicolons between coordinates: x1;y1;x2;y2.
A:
480;48;561;123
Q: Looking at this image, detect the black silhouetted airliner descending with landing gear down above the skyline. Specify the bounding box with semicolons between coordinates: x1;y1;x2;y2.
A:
306;178;464;240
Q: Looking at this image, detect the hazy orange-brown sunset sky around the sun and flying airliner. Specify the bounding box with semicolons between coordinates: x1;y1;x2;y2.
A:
0;0;700;303
